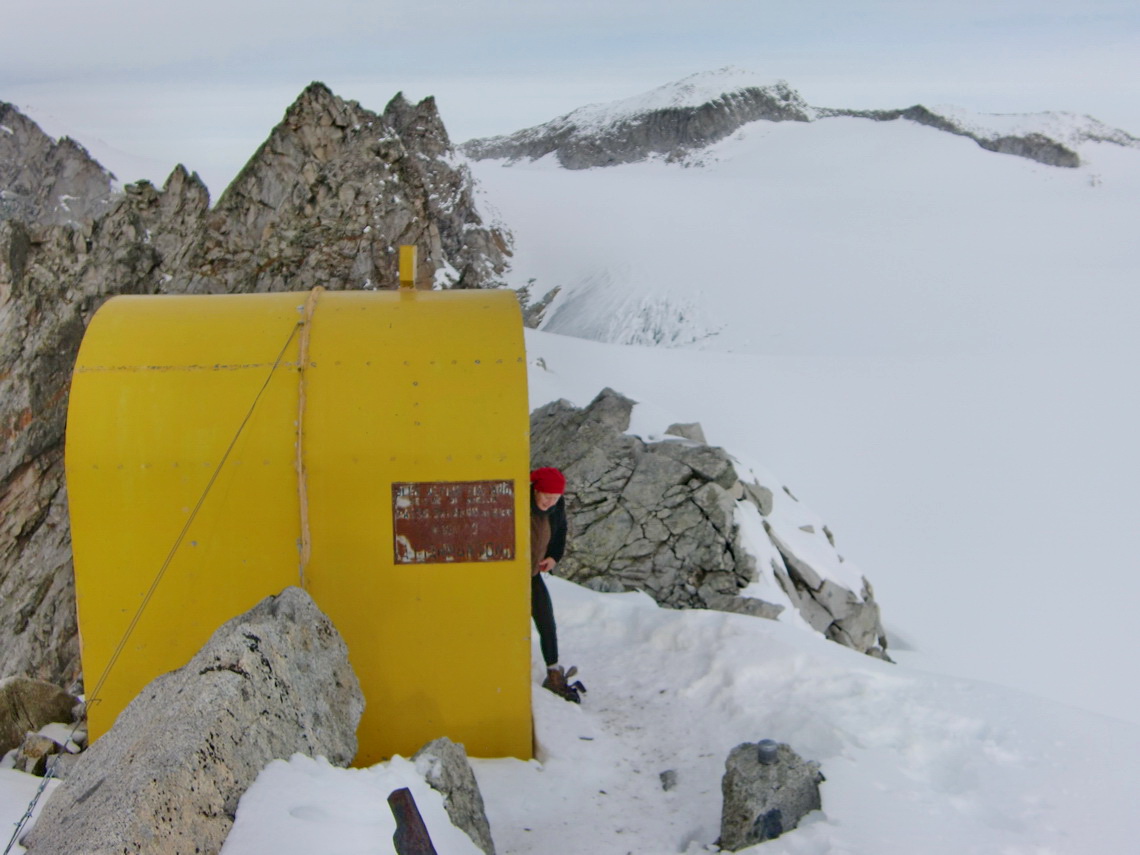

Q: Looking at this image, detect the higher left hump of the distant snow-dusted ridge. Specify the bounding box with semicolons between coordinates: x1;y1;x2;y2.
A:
459;81;813;169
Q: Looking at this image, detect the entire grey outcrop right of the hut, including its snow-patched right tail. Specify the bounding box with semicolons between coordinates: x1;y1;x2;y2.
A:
530;389;886;657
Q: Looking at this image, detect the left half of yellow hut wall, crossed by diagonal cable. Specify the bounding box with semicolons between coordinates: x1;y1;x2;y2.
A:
66;295;298;736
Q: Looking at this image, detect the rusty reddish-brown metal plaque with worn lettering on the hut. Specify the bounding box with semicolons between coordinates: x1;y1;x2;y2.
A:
392;481;514;564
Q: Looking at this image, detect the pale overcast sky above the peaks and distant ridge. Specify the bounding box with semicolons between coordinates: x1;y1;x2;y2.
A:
0;0;1140;196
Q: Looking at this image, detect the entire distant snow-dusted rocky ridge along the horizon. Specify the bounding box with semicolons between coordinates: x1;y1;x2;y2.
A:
459;68;1140;169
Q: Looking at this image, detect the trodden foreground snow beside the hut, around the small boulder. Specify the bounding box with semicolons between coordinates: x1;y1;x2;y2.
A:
98;579;1140;855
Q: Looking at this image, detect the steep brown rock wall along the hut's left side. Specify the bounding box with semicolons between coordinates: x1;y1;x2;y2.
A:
0;189;173;686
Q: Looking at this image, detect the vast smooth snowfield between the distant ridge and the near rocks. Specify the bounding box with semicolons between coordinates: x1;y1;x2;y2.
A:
472;92;1140;720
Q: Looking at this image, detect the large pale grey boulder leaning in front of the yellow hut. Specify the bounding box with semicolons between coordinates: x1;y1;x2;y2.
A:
23;588;364;855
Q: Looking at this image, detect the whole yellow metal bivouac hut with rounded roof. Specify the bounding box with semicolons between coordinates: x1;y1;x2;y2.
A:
66;279;531;765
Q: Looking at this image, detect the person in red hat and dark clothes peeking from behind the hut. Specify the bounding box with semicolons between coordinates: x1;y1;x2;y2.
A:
530;466;586;703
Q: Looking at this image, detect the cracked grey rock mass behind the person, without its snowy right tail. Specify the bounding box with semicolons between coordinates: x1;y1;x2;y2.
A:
530;389;780;617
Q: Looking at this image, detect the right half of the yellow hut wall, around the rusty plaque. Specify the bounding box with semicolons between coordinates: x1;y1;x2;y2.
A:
304;291;531;763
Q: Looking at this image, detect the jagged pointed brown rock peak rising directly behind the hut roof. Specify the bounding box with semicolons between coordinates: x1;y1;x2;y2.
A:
197;83;508;293
